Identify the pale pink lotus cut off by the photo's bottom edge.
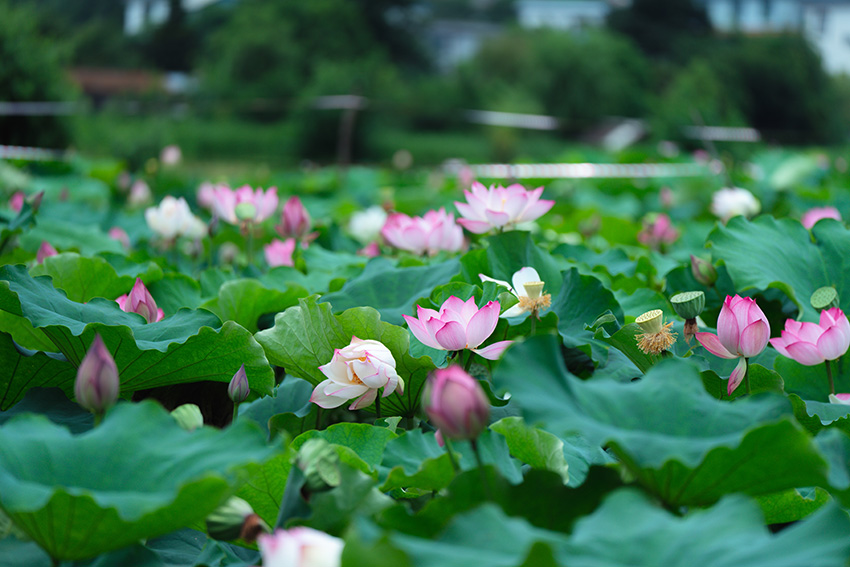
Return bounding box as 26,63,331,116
257,526,345,567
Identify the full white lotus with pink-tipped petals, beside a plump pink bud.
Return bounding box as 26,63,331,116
310,337,404,410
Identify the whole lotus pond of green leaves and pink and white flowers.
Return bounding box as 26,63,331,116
0,150,850,567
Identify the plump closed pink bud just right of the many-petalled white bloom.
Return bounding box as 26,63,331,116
422,366,490,439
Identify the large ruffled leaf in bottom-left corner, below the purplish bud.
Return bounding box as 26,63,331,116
0,402,274,559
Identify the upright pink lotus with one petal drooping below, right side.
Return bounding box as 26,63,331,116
695,295,770,395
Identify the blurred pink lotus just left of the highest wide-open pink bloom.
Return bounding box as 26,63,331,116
381,208,463,255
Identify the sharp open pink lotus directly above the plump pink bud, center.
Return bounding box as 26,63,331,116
403,296,513,360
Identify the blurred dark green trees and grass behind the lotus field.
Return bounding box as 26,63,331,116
0,0,850,165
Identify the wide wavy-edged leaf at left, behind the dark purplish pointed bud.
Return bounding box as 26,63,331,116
0,266,274,394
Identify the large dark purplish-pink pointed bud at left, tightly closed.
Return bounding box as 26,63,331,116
74,335,121,414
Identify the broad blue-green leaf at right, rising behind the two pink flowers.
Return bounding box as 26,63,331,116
709,216,850,321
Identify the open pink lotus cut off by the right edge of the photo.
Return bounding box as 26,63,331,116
770,307,850,366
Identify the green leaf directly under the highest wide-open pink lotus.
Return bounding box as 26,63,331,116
454,231,568,297
